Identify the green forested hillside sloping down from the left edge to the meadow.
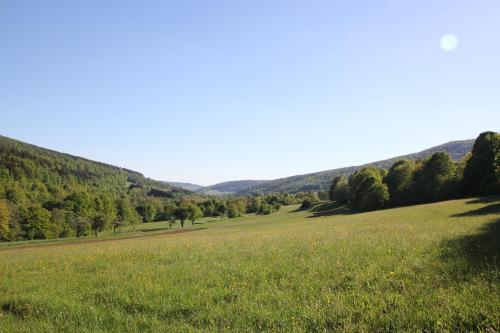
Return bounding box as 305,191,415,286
0,136,199,240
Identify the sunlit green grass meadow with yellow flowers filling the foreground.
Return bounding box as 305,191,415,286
0,198,500,333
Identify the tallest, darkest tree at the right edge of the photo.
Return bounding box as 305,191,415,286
462,132,500,195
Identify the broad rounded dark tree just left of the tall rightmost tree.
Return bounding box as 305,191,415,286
413,153,458,203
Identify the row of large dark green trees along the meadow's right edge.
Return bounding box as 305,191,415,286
329,132,500,211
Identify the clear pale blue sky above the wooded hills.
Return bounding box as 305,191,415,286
0,0,500,185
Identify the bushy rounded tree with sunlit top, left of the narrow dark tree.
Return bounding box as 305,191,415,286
349,167,389,211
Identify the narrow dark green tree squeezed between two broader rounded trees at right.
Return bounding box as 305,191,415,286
384,160,415,206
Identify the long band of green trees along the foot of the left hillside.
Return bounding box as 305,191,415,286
0,185,302,241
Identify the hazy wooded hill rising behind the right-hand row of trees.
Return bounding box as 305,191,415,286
240,140,474,194
